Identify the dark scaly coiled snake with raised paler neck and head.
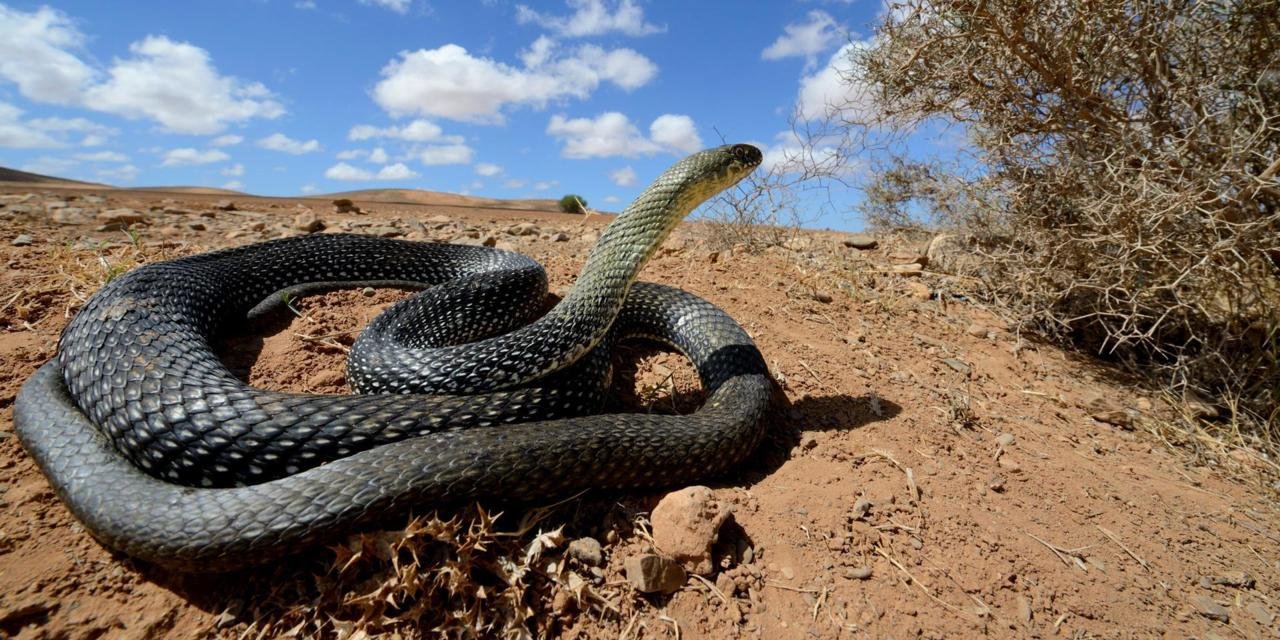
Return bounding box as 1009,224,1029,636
14,145,772,571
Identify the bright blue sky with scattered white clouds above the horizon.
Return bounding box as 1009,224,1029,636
0,0,901,228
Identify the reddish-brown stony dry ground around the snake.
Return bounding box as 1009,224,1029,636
0,186,1280,640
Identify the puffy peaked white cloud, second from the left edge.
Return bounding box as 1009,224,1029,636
83,36,284,134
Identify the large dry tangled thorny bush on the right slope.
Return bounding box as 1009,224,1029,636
849,0,1280,444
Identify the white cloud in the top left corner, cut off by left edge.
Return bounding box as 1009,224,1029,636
0,5,95,105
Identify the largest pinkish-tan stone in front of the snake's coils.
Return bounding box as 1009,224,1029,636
649,485,731,576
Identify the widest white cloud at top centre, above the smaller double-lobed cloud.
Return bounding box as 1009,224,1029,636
374,38,658,123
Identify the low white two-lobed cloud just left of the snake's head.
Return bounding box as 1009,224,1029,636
547,111,701,159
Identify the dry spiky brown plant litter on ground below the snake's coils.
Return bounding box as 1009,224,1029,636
244,504,608,639
